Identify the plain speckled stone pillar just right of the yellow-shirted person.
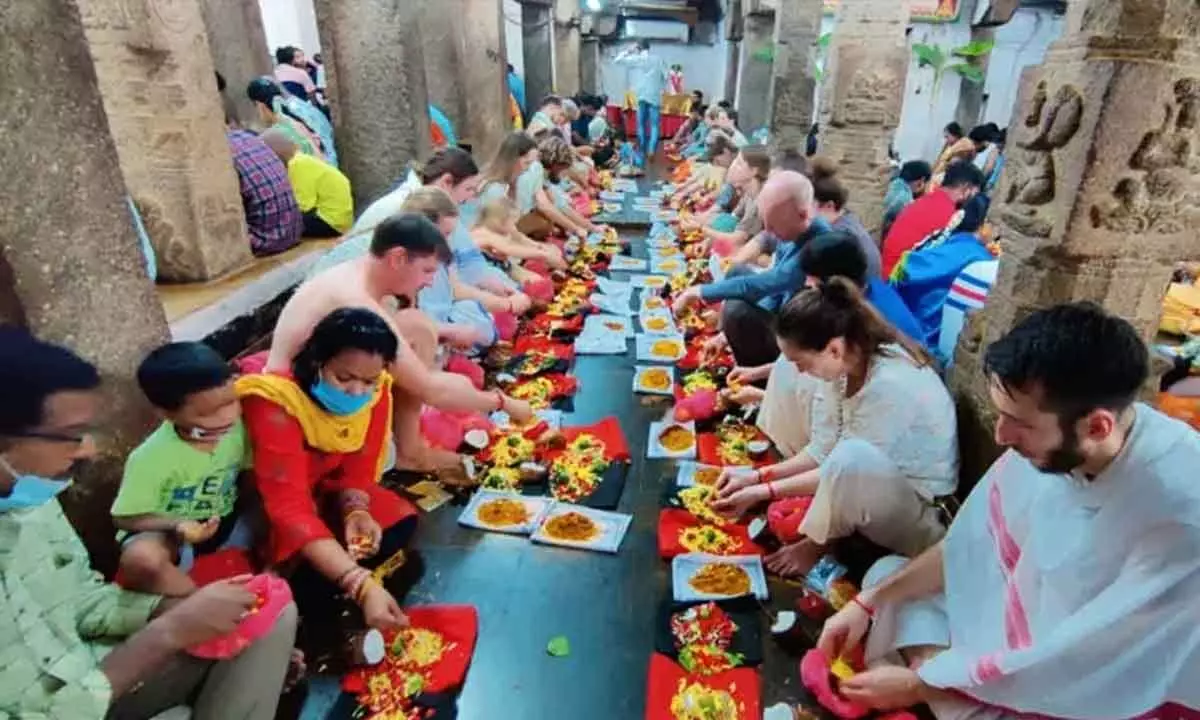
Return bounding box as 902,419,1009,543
316,0,430,208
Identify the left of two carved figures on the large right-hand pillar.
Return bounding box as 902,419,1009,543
1002,80,1084,238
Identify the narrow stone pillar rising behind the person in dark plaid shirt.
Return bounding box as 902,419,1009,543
200,0,274,125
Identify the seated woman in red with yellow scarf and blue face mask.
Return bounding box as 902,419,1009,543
236,308,416,629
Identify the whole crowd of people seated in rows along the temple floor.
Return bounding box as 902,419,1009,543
0,47,1200,720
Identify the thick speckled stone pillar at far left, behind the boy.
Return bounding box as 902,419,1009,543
0,0,168,570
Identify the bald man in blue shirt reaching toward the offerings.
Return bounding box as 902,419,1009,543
674,170,829,367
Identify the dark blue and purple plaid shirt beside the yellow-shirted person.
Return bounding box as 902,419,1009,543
226,130,304,254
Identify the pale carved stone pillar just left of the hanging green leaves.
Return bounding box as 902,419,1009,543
821,0,912,233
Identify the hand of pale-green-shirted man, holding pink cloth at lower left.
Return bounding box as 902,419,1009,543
155,575,257,649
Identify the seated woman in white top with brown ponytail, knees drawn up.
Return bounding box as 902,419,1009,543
714,277,959,576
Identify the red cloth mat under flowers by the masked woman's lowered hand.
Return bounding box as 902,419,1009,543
342,605,479,695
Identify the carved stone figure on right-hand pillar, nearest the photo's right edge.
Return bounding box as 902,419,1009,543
1088,78,1200,234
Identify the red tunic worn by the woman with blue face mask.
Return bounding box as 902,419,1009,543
241,386,416,563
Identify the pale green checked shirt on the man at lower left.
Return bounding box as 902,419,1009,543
0,500,161,720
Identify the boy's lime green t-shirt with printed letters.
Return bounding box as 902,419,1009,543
113,420,250,520
